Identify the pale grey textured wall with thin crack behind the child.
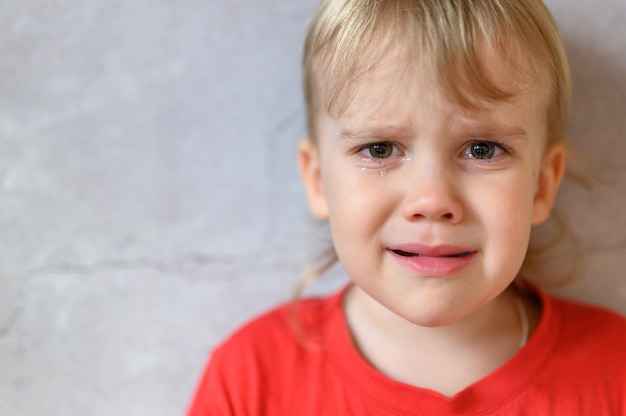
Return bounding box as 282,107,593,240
0,0,626,416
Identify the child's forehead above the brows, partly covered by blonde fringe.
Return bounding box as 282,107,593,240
318,42,552,128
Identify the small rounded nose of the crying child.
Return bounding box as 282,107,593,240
402,162,463,224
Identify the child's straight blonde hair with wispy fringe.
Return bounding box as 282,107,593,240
303,0,571,292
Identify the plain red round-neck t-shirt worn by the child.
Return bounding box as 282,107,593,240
188,291,626,416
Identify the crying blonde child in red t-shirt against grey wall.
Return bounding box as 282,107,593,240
189,0,626,416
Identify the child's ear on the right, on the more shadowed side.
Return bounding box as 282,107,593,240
532,143,566,225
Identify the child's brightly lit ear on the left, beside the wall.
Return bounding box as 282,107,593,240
298,139,328,220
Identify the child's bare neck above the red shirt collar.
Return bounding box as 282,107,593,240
345,287,525,395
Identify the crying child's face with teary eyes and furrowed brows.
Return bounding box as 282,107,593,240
300,46,564,326
